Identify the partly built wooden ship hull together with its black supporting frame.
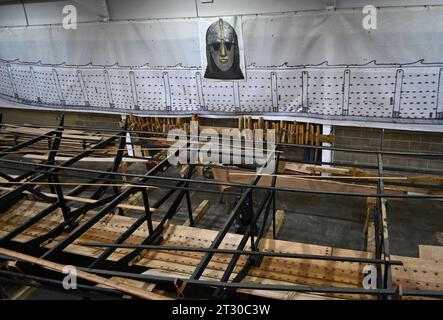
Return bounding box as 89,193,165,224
0,116,443,300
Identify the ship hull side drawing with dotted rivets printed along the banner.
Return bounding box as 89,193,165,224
0,59,443,123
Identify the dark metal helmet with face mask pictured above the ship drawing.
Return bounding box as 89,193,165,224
205,19,244,80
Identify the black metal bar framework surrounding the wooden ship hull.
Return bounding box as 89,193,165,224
0,116,443,299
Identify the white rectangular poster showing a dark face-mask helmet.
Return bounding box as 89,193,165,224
199,17,246,80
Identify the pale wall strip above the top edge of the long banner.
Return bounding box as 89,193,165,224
0,0,443,27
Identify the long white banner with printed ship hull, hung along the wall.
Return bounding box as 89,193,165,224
0,7,443,126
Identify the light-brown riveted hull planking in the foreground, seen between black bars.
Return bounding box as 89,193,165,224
0,200,443,299
